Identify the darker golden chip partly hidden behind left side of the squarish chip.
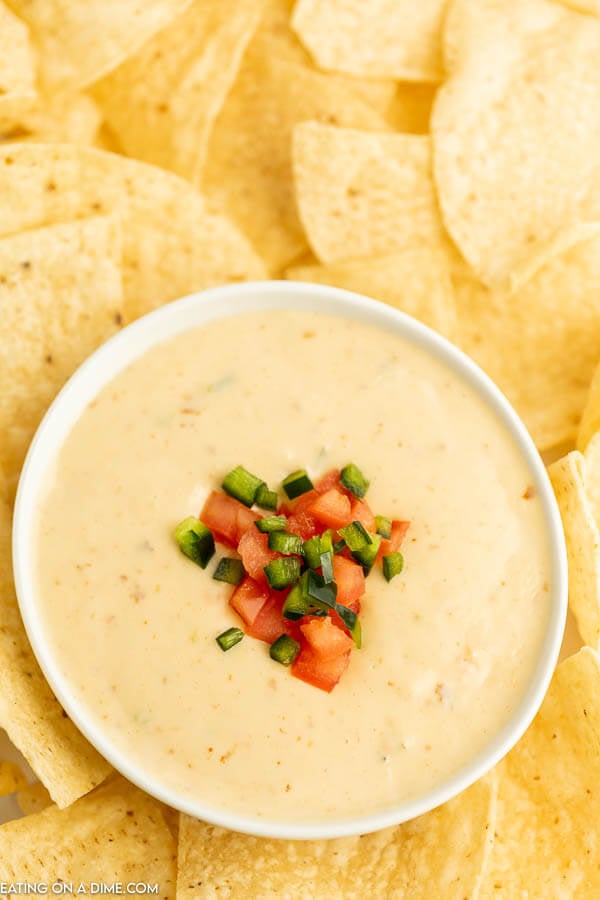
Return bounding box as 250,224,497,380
201,7,386,272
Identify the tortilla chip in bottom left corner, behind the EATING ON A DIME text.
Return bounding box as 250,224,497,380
0,778,177,898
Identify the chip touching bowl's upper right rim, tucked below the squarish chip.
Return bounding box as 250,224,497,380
285,249,456,339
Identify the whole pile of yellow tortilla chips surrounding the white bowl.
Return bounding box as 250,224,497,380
0,0,600,900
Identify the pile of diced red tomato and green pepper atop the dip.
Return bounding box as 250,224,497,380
175,463,410,691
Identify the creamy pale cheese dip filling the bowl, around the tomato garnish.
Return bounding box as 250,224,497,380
36,311,550,821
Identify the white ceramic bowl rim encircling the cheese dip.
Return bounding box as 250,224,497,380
13,281,567,838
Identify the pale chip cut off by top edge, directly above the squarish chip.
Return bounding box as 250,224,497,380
292,0,447,81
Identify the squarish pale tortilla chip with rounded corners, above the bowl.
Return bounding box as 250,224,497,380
293,122,447,263
